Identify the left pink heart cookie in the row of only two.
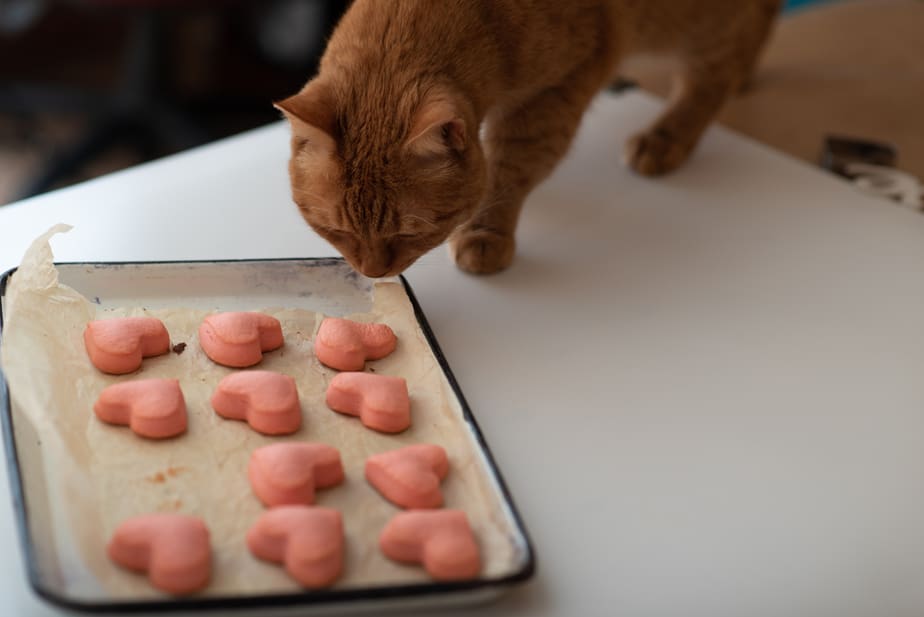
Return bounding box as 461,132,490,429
247,441,343,507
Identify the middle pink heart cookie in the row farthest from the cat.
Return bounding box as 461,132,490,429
247,506,344,588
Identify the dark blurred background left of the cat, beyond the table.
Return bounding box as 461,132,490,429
0,0,349,204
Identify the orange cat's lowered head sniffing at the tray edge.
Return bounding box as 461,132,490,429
276,78,486,277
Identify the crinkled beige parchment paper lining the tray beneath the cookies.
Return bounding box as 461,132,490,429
2,226,522,598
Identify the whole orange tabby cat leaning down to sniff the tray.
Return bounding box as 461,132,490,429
277,0,781,277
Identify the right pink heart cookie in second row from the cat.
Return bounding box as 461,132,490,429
327,373,411,433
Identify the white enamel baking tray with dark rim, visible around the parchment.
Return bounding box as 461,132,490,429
0,258,535,614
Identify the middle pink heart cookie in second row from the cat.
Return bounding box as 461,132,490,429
212,371,302,435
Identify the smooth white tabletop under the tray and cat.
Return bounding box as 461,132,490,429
0,94,924,617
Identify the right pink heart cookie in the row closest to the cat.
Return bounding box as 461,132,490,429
314,317,398,371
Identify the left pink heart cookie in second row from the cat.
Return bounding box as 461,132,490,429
93,379,187,439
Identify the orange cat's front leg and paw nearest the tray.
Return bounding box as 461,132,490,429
449,67,606,274
